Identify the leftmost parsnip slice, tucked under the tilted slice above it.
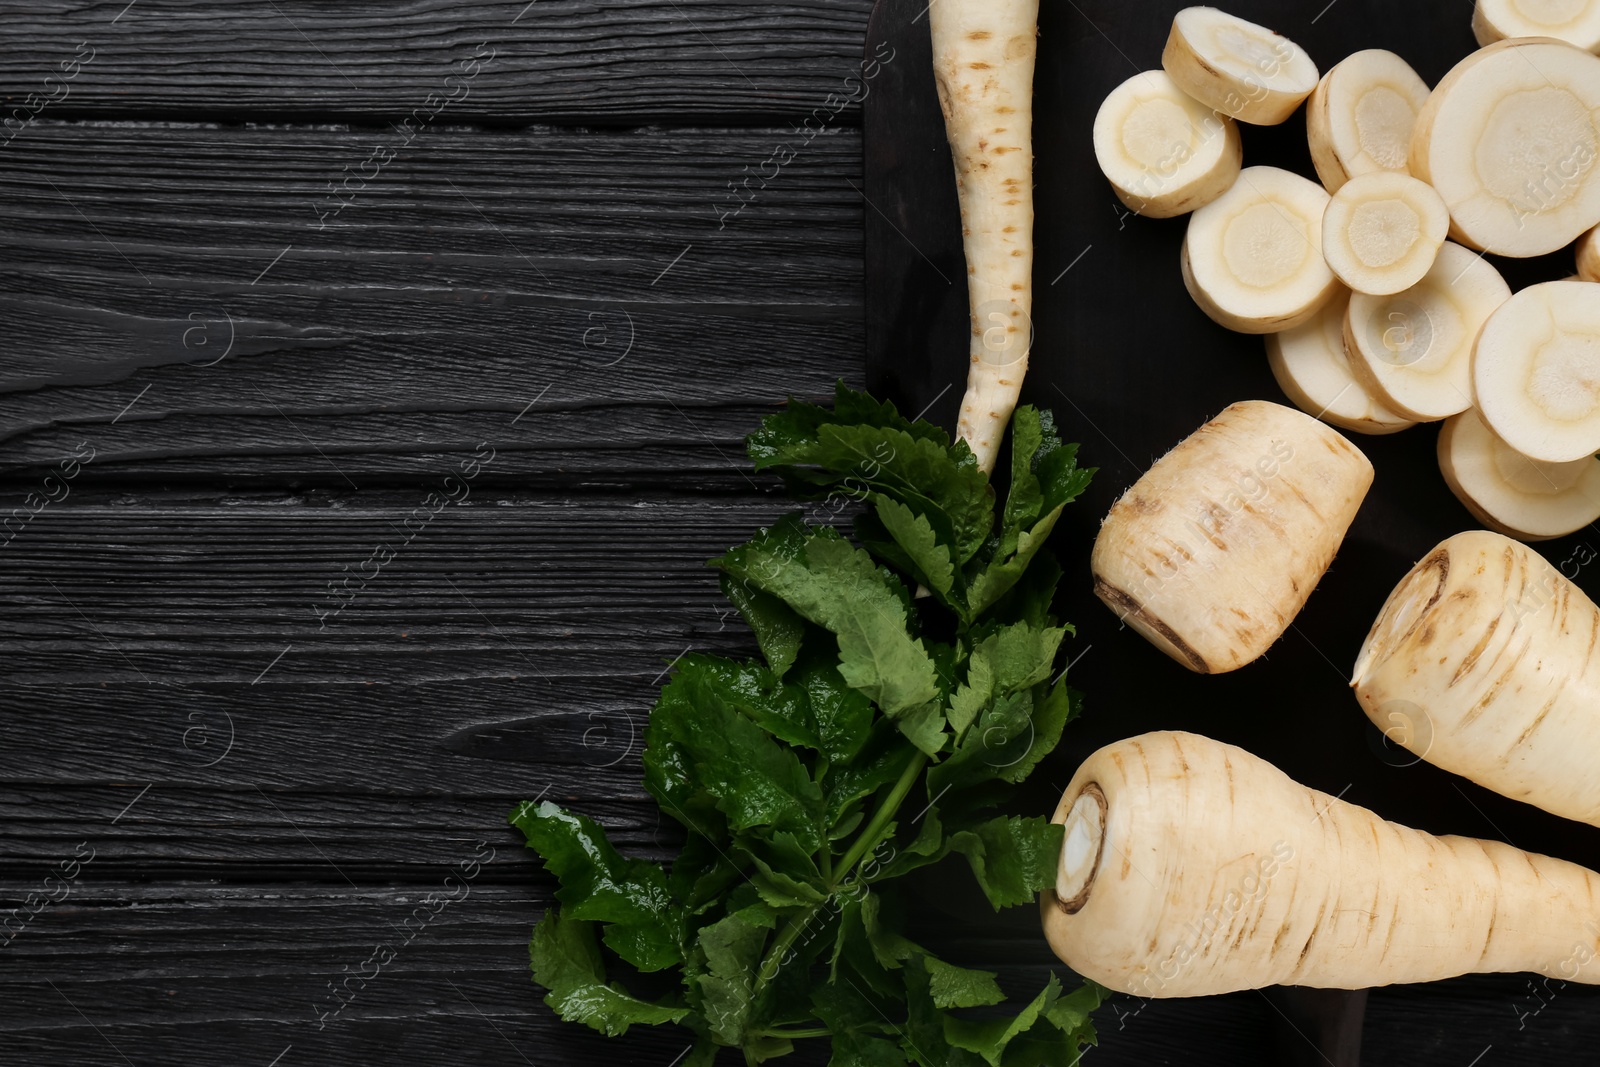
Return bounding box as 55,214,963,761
1094,70,1243,219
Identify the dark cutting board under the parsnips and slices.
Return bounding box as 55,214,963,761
864,0,1600,1067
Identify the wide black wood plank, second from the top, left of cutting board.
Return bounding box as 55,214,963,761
0,125,864,493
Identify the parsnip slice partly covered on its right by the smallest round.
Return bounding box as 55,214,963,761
1182,166,1339,333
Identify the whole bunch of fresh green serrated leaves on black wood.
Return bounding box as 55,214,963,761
512,386,1104,1067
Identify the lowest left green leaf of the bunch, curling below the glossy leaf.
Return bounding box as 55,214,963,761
528,907,688,1037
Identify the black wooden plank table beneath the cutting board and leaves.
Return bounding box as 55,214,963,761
0,0,1600,1067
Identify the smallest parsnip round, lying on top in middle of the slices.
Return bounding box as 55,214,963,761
1322,171,1450,296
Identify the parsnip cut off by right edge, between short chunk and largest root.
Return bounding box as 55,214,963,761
1350,530,1600,825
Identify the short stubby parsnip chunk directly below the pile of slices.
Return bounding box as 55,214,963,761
1090,400,1373,673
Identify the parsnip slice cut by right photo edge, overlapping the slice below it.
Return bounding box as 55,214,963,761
1472,282,1600,462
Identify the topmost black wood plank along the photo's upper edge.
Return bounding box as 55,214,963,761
0,0,872,125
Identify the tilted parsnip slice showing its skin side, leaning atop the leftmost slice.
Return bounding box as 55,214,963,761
1162,8,1317,126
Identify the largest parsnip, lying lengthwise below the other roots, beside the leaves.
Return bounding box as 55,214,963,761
1040,733,1600,997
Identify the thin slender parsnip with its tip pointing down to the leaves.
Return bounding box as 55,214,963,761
928,0,1038,470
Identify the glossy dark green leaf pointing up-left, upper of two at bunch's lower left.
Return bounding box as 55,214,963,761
510,801,683,971
